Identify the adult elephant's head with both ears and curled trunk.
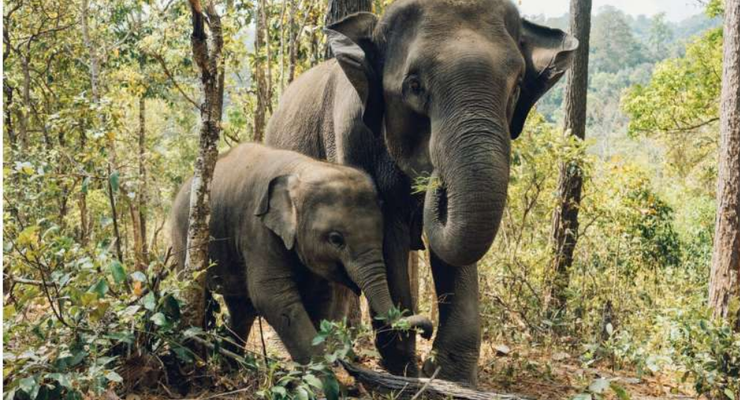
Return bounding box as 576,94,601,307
326,0,578,266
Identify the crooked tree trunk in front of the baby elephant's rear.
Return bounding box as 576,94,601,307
182,0,225,328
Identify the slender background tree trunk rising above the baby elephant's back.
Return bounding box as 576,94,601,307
252,0,270,143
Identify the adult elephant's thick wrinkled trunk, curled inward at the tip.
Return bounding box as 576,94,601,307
424,100,510,266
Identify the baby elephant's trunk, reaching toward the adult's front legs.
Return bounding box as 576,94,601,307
346,250,434,339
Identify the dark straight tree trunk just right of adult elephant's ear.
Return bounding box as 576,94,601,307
545,0,591,310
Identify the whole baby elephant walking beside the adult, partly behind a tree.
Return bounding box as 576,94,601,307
172,144,432,363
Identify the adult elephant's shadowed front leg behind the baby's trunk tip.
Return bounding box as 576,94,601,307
373,218,419,376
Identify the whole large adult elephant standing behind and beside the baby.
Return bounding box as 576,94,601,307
266,0,577,384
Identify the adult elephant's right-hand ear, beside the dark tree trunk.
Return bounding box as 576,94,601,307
509,19,578,139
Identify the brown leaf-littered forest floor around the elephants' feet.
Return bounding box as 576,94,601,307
117,323,696,400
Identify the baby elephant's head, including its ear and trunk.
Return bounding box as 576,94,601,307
255,165,432,338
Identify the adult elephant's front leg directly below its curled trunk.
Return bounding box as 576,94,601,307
423,251,481,386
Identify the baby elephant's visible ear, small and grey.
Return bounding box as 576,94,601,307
254,175,298,250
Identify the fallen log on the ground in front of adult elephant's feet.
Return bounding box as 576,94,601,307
342,362,532,400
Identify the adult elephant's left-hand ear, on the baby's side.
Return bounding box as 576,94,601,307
324,12,378,111
